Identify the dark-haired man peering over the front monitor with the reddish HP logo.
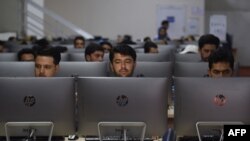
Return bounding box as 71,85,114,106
208,47,234,77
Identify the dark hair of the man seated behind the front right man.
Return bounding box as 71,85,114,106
198,34,220,49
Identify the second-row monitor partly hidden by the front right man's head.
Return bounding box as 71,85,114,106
174,62,239,77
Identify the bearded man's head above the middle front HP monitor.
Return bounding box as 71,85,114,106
109,45,136,77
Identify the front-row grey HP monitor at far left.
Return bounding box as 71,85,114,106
0,77,75,136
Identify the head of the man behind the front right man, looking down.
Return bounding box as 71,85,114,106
198,34,220,62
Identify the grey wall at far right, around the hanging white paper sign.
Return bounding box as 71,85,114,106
205,0,250,66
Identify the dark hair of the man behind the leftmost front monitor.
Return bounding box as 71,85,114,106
36,47,61,65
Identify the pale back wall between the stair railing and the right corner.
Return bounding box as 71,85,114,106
45,0,204,39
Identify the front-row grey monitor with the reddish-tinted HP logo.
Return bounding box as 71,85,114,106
174,77,250,136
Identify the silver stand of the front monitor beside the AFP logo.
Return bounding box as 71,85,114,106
196,121,243,141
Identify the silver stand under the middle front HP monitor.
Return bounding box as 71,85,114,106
98,122,146,141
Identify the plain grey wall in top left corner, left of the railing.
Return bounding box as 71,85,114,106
0,0,22,34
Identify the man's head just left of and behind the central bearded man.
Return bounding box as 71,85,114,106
85,43,104,62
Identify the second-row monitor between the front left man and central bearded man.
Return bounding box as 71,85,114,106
56,62,108,77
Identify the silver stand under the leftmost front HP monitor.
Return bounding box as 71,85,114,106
5,122,54,141
